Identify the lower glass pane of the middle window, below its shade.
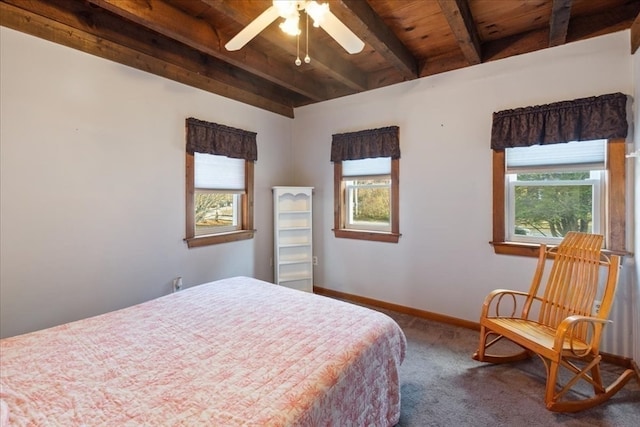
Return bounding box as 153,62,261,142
346,177,391,231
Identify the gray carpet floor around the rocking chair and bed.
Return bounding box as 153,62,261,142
372,307,640,427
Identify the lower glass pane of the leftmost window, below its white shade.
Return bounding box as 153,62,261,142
195,190,241,236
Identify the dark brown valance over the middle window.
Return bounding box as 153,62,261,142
331,126,400,162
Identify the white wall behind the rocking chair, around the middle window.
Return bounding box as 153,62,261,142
293,31,637,358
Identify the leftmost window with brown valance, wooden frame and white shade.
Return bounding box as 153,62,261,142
185,119,257,248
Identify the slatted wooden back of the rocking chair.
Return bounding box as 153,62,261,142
538,232,608,340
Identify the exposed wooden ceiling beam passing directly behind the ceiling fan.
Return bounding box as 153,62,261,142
202,0,369,91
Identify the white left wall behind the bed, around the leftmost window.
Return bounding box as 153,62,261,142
0,27,292,337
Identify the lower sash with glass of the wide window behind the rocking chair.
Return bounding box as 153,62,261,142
508,171,602,242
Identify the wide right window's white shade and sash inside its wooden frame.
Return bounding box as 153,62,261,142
505,140,606,244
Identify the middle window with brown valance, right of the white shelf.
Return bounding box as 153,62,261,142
331,126,400,243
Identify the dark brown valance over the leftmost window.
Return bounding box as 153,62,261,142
187,117,258,161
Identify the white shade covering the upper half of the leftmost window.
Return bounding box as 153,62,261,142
194,153,245,190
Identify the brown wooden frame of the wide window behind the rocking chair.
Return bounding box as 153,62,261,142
490,138,628,257
